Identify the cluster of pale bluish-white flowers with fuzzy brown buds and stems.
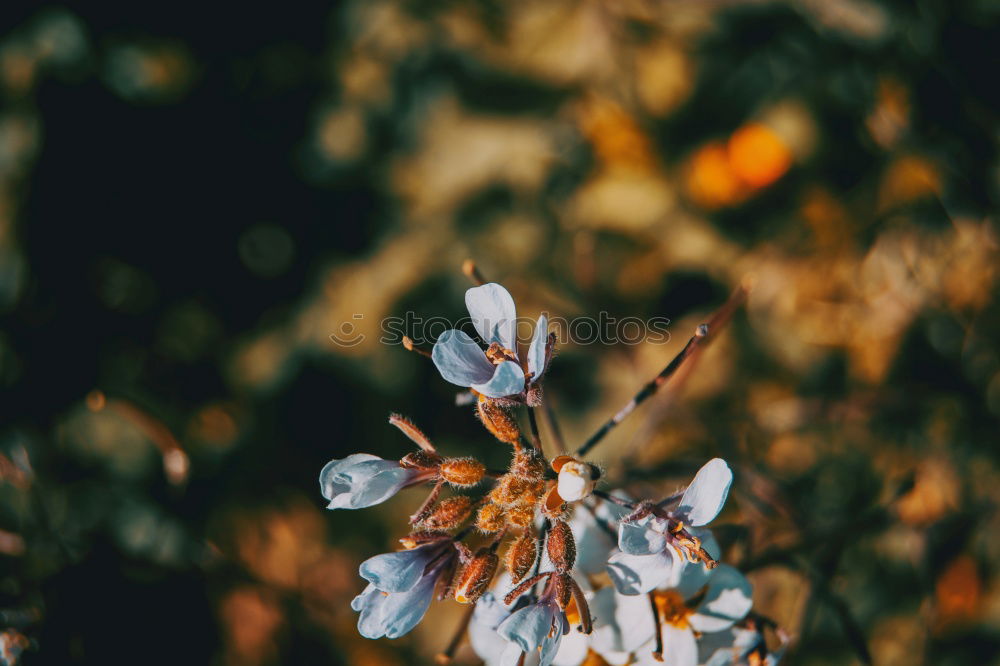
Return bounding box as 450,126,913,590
320,272,784,666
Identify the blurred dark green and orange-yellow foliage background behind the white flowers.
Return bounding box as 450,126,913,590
0,0,1000,666
